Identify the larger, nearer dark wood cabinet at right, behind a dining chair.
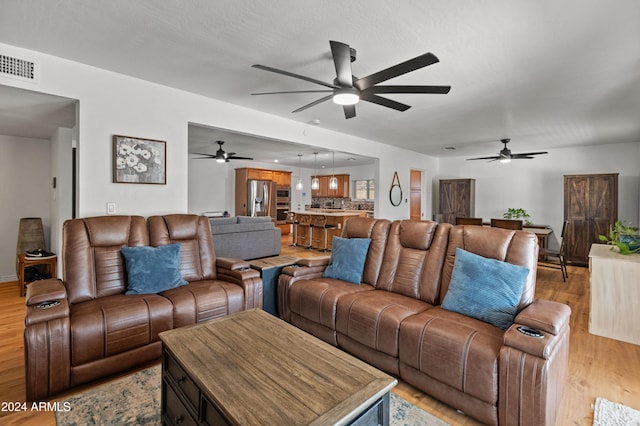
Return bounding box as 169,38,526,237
564,173,618,266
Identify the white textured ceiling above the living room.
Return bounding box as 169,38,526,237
0,0,640,164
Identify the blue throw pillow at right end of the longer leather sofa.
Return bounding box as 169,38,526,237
442,248,529,330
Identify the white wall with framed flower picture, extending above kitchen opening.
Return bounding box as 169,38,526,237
0,42,437,223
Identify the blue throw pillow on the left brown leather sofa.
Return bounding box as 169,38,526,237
121,244,187,294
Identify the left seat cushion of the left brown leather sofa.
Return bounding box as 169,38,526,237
70,294,173,366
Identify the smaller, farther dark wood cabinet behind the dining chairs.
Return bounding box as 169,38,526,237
440,179,476,225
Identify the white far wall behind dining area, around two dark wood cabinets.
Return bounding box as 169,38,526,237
434,142,640,250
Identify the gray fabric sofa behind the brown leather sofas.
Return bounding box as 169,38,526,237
209,216,280,260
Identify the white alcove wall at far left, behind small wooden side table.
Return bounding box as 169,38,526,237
0,135,51,282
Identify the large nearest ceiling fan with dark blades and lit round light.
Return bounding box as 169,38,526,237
252,41,451,118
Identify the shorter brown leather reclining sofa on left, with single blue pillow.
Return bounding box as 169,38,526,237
24,214,262,401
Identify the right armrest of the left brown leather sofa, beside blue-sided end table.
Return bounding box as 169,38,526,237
216,257,262,309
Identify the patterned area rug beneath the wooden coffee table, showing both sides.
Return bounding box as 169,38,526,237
56,365,448,426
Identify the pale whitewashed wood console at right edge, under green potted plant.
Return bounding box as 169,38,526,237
589,244,640,345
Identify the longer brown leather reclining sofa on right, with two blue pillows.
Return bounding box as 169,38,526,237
278,218,571,425
